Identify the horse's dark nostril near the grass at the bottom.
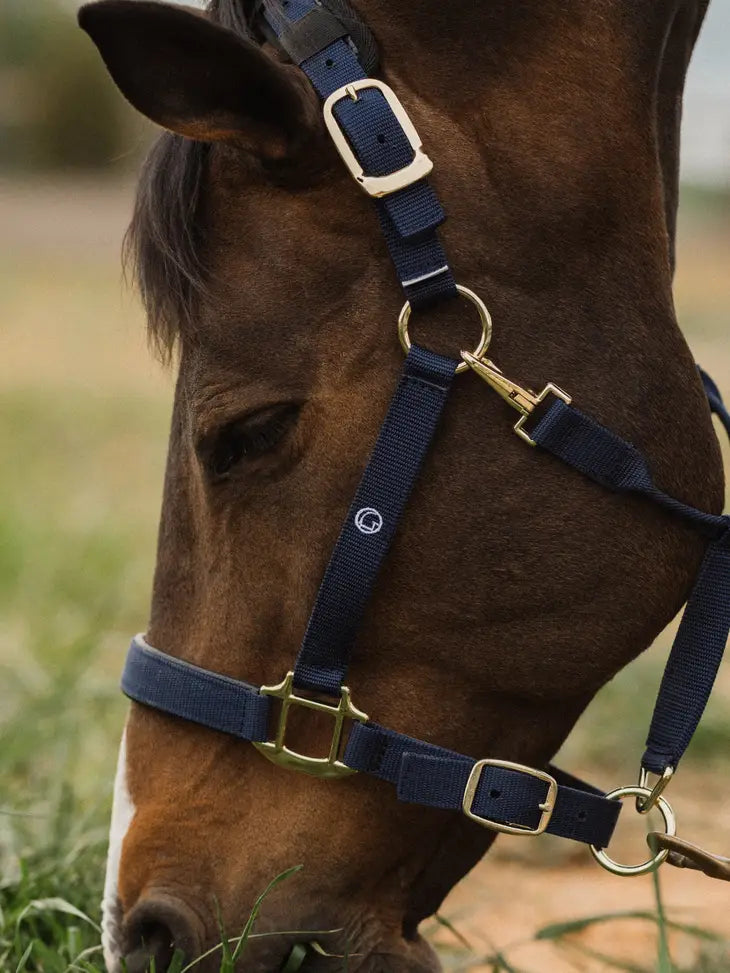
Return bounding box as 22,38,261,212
124,896,200,973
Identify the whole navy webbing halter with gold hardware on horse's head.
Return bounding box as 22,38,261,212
122,0,730,875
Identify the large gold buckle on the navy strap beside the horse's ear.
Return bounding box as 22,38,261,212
324,78,433,197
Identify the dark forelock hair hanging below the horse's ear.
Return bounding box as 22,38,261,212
124,0,255,358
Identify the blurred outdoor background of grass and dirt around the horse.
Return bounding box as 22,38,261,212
0,0,730,973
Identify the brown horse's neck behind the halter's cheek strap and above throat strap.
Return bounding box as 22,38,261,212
346,0,713,505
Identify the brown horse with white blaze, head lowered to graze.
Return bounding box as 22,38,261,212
79,0,723,973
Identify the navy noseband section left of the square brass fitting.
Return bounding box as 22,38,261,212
122,635,270,741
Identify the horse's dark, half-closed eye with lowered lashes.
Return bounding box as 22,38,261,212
198,402,300,480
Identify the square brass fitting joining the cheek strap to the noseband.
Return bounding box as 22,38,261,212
254,672,368,780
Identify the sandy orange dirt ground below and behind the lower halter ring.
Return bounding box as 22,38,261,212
438,770,730,973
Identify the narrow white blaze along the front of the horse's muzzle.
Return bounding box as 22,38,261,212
101,730,135,973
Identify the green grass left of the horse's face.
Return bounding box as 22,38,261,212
0,390,165,973
